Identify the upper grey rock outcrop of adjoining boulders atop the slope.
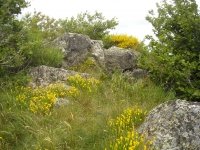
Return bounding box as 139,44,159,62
54,33,146,78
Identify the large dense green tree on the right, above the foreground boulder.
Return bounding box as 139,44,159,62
141,0,200,101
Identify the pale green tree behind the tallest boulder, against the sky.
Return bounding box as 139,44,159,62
61,12,118,40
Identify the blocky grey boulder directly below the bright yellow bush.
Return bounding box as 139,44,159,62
104,47,138,72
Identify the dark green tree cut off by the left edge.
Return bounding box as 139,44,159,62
0,0,27,74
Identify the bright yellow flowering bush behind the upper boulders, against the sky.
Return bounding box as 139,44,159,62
104,34,139,50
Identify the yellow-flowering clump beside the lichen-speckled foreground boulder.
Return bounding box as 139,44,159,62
108,108,151,150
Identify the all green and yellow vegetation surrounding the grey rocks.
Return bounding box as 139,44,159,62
0,0,200,150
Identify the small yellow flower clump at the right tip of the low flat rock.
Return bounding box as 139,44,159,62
67,74,100,93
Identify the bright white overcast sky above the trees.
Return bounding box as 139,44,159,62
23,0,200,40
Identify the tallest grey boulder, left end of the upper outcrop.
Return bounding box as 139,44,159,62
55,33,92,68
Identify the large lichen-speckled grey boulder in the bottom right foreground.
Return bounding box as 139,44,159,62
140,100,200,150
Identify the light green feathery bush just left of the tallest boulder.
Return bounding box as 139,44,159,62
22,12,64,67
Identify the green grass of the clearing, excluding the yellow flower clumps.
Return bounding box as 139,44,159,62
0,68,174,150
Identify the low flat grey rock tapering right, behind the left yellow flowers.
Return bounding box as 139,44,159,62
29,66,89,87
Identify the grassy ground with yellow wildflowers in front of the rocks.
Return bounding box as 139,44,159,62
0,73,173,150
